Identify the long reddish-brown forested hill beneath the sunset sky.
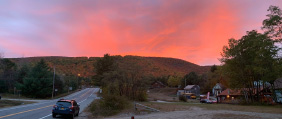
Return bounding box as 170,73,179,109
10,56,210,77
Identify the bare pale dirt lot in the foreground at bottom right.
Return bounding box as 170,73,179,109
105,104,282,119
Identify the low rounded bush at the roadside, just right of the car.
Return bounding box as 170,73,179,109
90,95,129,117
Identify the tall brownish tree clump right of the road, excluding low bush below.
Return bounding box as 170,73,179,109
94,54,147,101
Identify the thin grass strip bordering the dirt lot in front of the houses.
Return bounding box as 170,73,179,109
142,102,282,114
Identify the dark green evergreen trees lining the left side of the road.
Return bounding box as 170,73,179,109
0,58,90,98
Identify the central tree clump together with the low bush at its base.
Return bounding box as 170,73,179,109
90,54,148,116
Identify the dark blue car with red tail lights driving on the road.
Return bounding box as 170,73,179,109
52,99,80,119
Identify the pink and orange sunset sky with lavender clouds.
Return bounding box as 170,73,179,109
0,0,282,65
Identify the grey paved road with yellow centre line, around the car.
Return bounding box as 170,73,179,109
0,88,99,119
